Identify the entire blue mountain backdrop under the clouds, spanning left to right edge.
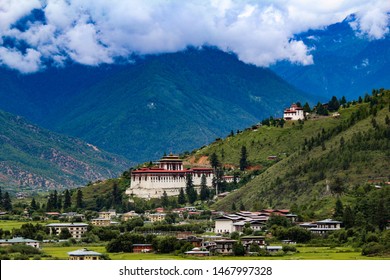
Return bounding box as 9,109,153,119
0,16,390,190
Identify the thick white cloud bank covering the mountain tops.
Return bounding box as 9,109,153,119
0,0,390,73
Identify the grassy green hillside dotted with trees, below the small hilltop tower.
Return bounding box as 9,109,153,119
192,90,390,217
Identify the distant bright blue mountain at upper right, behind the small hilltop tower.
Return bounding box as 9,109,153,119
271,15,390,100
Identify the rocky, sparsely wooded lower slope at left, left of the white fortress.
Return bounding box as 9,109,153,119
0,111,130,191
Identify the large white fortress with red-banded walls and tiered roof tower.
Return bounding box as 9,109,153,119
126,154,214,199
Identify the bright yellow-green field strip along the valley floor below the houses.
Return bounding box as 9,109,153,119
42,245,390,260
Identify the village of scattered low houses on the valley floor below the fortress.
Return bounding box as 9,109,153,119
0,203,348,260
